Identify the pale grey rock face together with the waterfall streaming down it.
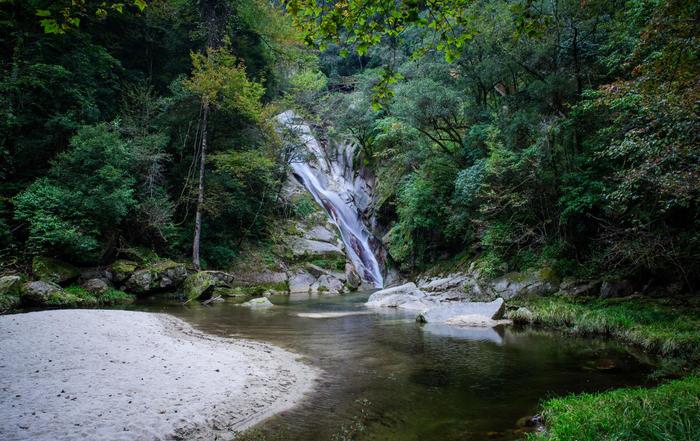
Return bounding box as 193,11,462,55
277,111,384,287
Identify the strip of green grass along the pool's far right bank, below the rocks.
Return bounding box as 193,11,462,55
508,297,700,362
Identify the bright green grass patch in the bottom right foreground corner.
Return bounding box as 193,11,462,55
527,377,700,441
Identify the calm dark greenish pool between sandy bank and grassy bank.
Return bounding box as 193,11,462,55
137,293,649,441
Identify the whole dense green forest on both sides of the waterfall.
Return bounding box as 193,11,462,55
0,0,700,290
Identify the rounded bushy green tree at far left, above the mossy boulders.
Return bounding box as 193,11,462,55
14,124,136,261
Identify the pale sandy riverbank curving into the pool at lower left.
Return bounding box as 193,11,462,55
0,310,318,440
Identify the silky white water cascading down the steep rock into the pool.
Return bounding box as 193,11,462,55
277,110,384,288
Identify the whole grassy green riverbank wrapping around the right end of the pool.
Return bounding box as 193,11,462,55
509,296,700,441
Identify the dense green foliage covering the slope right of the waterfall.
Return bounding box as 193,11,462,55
296,0,700,287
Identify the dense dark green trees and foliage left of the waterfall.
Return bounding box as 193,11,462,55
0,0,313,266
